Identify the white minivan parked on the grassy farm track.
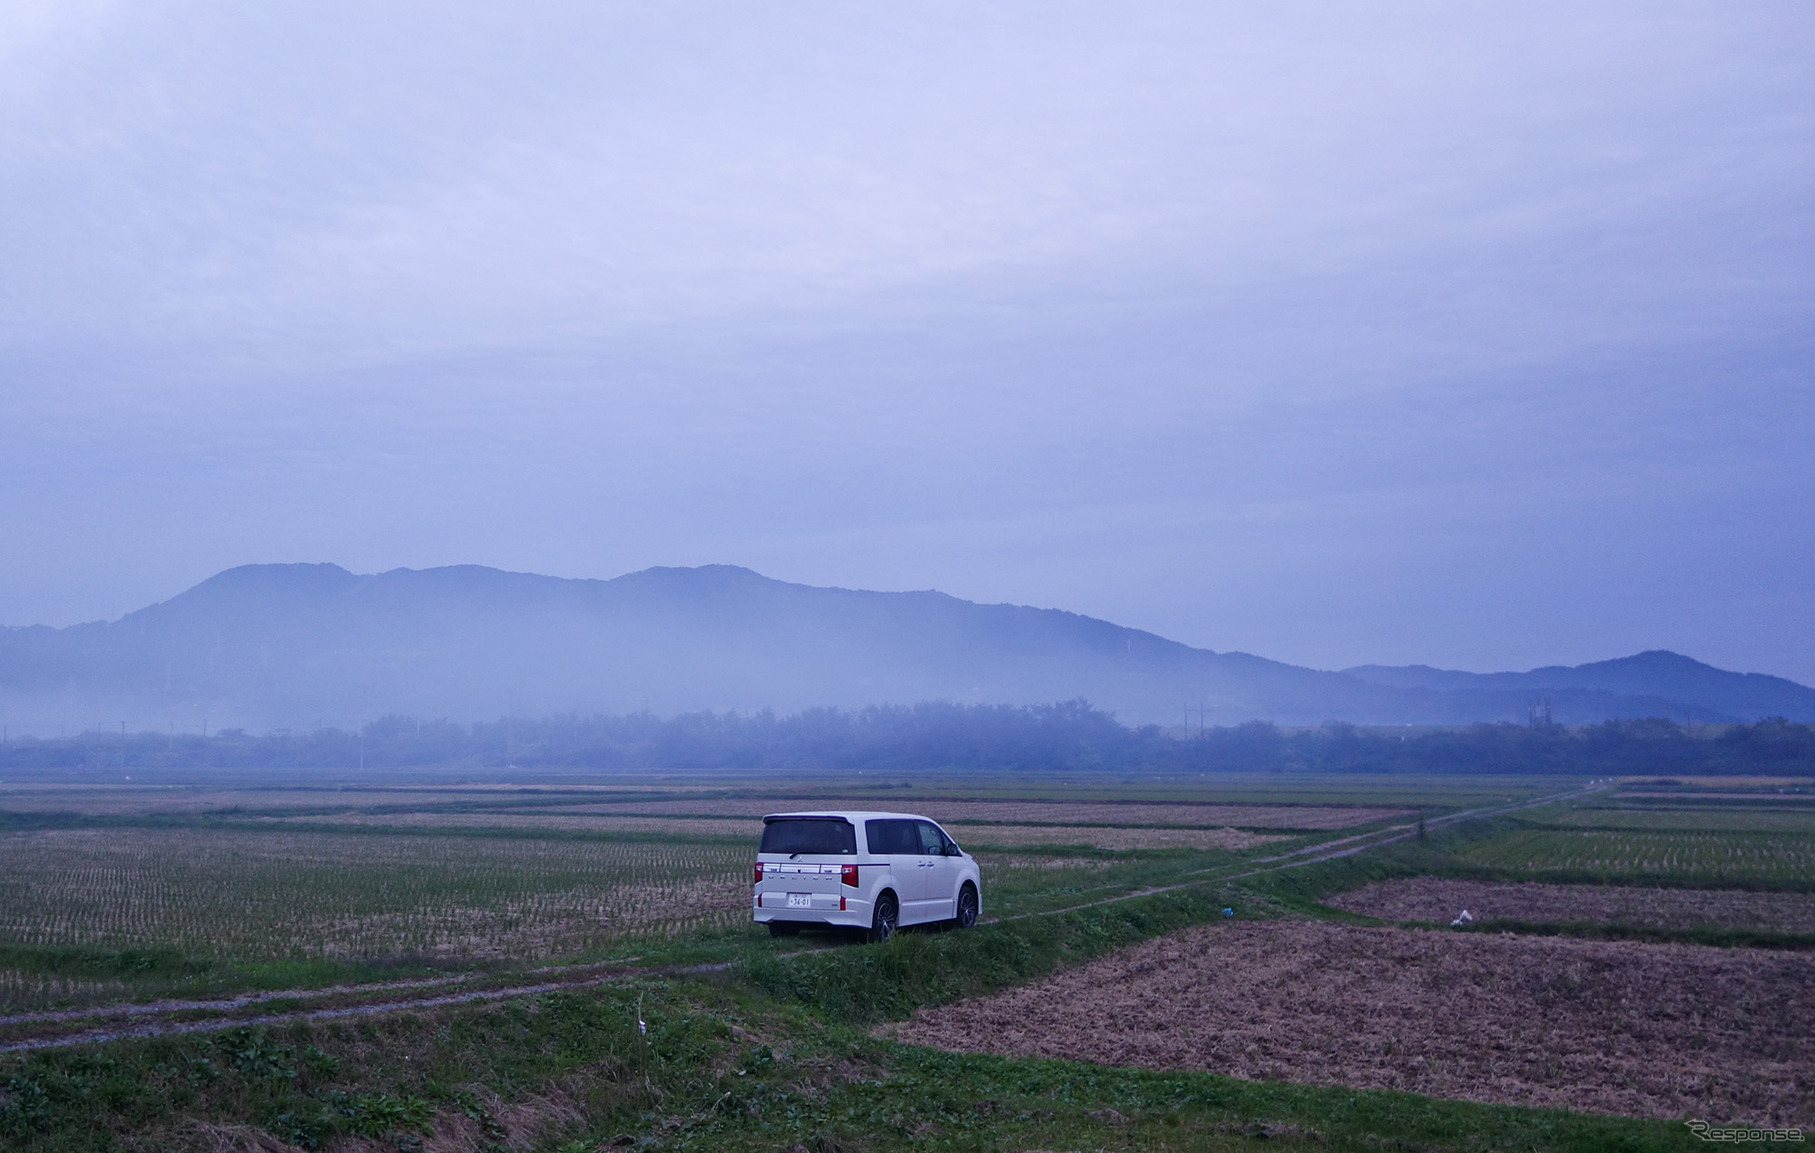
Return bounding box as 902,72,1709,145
753,812,984,941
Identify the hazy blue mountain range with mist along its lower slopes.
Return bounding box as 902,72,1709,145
0,565,1815,735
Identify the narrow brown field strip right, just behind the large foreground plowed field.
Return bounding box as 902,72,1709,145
1325,877,1815,933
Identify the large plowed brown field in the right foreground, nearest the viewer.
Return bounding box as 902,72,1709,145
884,921,1815,1126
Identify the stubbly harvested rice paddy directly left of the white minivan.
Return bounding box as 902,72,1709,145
0,828,750,961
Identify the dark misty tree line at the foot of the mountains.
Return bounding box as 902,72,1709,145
0,701,1815,775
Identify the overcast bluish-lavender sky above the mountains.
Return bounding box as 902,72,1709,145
0,0,1815,683
